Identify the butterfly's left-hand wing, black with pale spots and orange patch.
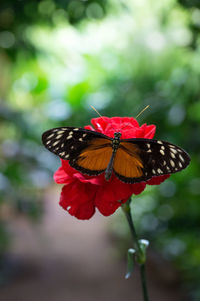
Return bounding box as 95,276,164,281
42,127,112,176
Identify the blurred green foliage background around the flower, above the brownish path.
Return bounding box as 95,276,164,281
0,0,200,300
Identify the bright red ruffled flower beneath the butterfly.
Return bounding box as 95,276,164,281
54,117,169,219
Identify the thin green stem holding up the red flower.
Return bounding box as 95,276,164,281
122,200,149,301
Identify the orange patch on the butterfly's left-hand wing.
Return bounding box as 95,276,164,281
76,138,112,171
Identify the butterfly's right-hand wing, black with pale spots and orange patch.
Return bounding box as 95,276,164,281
113,138,190,183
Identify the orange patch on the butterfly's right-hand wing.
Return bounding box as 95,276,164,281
113,142,143,178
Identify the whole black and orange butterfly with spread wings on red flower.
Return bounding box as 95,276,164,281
42,127,190,183
